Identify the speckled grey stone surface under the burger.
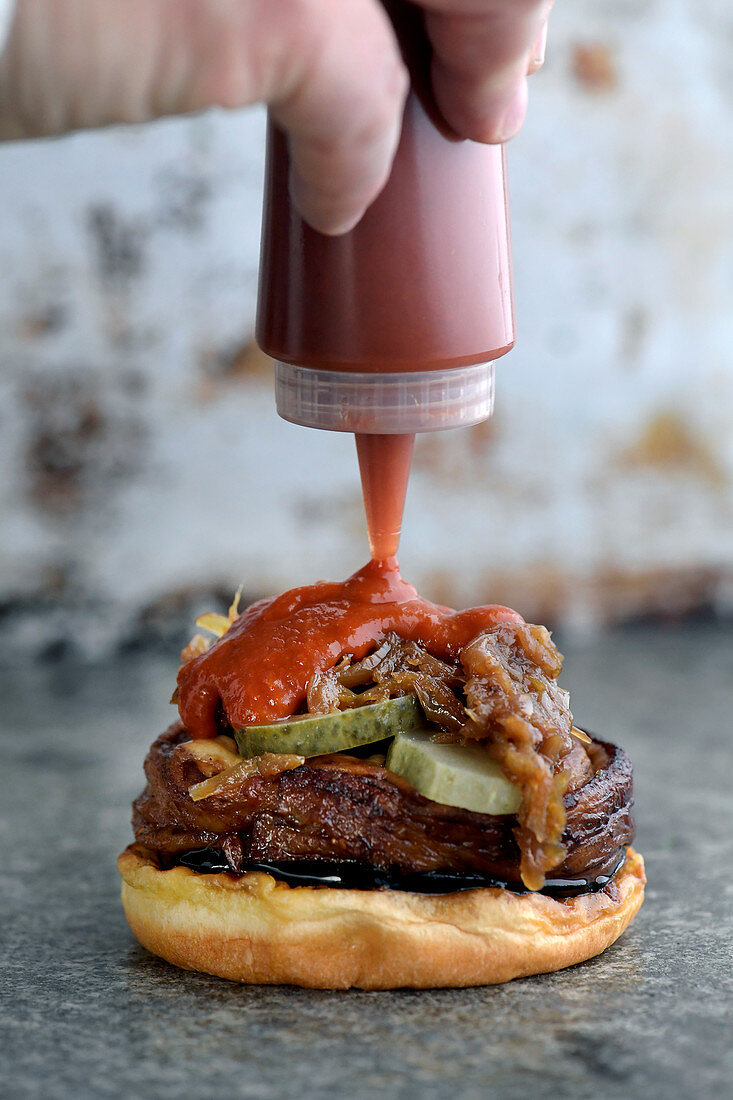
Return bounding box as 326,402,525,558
0,627,733,1100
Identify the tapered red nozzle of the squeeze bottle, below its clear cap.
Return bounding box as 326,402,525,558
355,435,415,561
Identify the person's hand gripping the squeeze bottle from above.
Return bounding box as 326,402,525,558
0,0,551,233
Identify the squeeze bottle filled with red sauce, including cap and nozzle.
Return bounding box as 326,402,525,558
256,4,514,559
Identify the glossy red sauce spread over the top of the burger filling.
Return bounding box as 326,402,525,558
178,558,523,739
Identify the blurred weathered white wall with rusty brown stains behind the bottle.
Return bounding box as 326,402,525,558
0,0,733,659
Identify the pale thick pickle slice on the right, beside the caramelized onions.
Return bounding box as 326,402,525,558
385,732,522,814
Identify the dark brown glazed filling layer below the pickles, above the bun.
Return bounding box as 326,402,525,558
133,723,634,882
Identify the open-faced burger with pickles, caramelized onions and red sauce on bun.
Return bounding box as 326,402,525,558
118,561,645,989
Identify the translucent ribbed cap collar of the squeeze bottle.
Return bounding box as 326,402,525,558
275,362,494,436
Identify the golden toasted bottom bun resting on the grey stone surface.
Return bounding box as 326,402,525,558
118,844,646,989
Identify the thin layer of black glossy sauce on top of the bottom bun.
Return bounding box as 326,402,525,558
175,848,626,899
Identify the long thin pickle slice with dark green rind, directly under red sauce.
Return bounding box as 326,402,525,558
234,695,425,757
